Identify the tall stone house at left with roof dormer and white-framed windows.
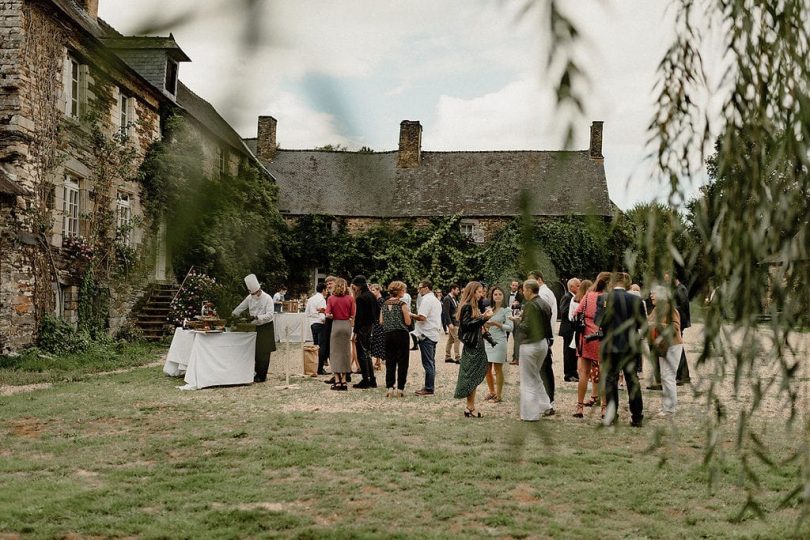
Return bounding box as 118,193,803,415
0,0,271,353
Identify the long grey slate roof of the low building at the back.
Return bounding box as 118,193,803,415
246,148,612,218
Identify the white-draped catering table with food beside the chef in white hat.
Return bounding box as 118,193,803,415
163,328,256,390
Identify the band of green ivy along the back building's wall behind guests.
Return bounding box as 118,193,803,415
283,215,635,291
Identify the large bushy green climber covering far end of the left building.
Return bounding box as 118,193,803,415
138,115,287,306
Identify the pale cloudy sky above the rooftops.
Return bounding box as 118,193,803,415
99,0,716,209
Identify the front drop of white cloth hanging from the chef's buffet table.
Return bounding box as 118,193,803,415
180,332,256,389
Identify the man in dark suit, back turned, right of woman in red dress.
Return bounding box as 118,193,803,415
599,272,645,427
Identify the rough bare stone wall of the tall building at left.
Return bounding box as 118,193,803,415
0,0,160,353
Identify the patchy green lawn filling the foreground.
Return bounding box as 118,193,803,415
0,340,810,539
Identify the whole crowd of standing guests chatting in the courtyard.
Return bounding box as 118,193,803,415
288,272,689,426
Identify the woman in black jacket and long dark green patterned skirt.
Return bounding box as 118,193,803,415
453,281,492,418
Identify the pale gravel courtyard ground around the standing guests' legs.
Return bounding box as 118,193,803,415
268,324,810,421
